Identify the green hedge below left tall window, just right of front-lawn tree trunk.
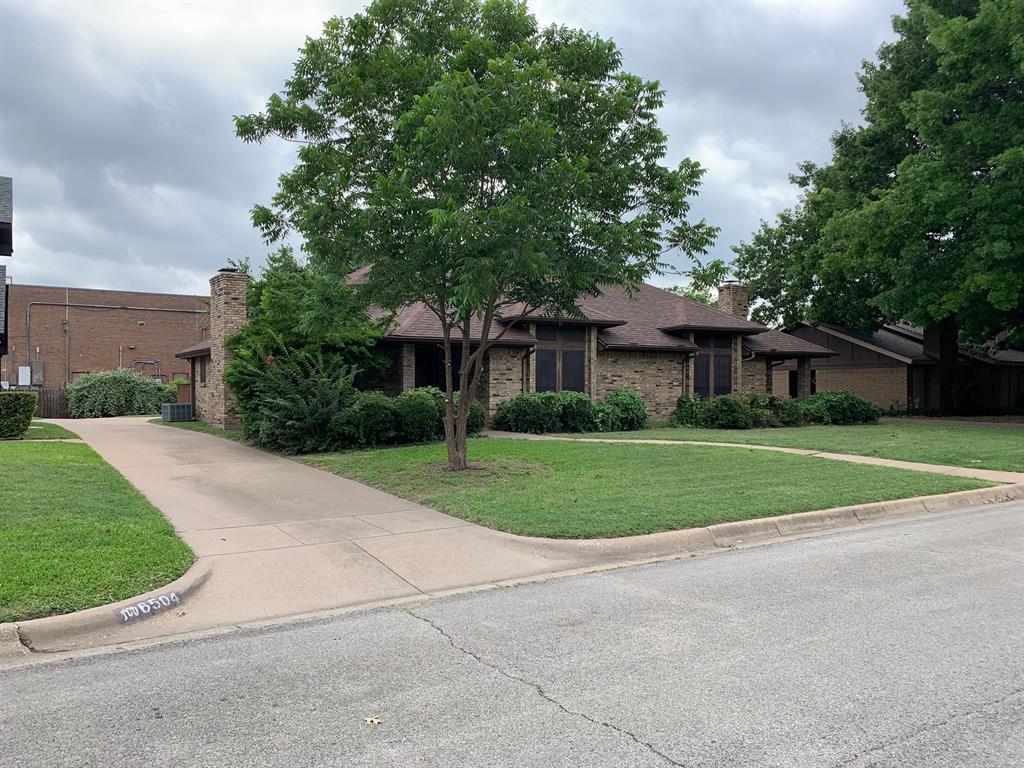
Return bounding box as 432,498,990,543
492,389,647,434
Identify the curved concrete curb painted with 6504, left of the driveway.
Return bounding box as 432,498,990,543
8,558,213,658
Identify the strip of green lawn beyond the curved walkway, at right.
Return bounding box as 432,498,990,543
594,419,1024,472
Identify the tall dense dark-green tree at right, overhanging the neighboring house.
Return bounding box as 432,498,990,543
733,0,1024,408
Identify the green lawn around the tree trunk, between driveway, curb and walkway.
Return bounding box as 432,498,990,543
305,438,988,539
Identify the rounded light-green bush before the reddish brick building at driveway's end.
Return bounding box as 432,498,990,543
68,369,177,419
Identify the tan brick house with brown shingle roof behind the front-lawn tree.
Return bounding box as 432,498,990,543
349,268,831,418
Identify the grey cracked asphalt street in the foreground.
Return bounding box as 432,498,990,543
0,503,1024,768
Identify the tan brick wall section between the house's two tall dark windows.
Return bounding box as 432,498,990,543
594,350,685,419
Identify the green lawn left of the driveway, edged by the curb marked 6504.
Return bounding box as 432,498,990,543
0,442,195,622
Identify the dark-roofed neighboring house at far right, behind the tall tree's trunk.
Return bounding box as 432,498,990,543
774,323,1024,413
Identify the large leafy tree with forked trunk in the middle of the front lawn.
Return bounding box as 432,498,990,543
237,0,716,469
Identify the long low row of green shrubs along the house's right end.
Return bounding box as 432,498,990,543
672,390,882,429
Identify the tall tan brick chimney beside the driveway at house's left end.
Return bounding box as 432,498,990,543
207,267,249,429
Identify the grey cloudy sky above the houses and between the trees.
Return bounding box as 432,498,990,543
0,0,901,293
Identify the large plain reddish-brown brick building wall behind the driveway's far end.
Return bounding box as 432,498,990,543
0,284,207,388
